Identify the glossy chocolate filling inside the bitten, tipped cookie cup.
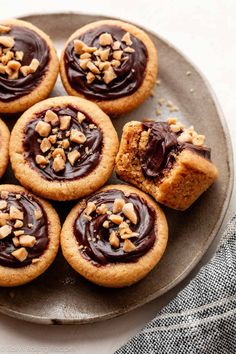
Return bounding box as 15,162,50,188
140,122,211,179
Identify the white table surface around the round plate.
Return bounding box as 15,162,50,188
0,0,236,354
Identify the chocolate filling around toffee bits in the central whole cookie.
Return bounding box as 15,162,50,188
23,106,103,181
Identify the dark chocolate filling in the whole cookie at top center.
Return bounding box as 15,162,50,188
64,25,148,100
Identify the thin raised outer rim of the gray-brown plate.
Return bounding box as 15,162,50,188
0,11,234,325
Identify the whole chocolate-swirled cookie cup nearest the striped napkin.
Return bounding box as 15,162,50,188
61,185,168,288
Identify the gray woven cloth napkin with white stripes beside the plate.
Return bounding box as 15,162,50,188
116,215,236,354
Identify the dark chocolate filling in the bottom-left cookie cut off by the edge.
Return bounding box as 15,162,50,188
0,193,48,268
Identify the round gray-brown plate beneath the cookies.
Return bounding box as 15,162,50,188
0,14,233,324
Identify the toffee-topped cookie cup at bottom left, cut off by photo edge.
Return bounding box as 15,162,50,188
0,184,60,286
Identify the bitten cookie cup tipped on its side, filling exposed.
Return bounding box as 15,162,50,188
115,118,218,210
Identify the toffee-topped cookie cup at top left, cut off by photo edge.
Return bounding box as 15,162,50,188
0,20,59,113
